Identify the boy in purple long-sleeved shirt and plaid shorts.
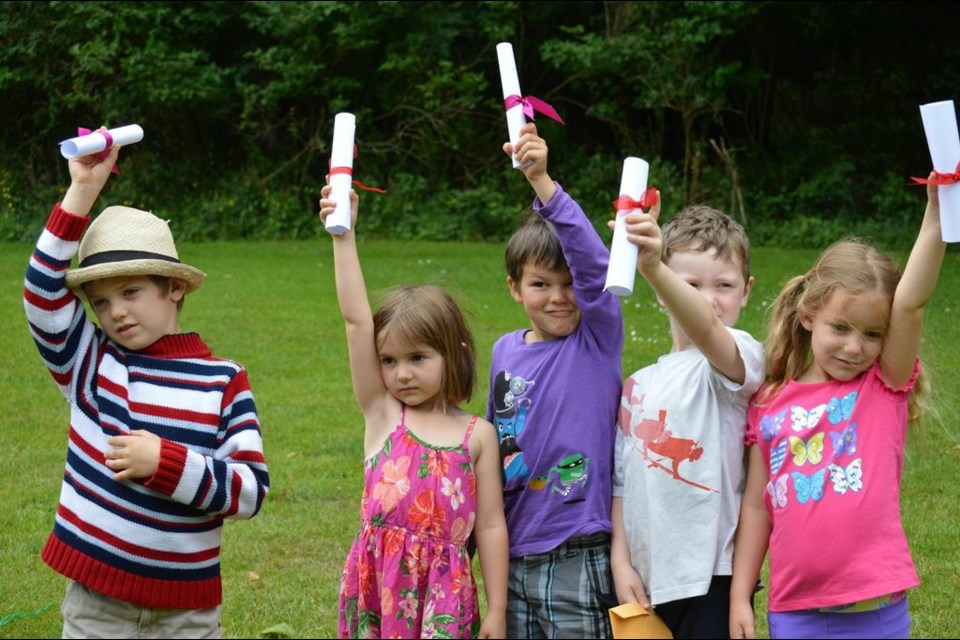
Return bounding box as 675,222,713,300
487,123,623,638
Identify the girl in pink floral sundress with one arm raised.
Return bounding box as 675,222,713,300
320,186,508,638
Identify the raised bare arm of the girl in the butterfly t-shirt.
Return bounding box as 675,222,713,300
880,180,947,389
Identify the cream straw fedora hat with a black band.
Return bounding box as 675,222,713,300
67,206,207,298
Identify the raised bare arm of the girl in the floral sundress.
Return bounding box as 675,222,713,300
320,185,387,424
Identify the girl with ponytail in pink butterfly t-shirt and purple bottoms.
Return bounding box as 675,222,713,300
730,174,946,638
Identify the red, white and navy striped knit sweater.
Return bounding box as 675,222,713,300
24,204,269,609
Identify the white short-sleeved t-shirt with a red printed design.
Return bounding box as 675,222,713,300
613,328,765,605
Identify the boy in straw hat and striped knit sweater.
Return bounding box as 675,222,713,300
24,134,269,638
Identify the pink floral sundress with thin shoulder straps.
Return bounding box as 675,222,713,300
338,406,480,638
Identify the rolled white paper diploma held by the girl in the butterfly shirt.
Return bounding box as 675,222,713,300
920,100,960,242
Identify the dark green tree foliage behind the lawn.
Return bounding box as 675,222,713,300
0,0,960,248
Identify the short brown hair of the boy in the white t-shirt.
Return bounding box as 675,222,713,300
663,204,750,282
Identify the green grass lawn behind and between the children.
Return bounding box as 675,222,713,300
0,238,960,638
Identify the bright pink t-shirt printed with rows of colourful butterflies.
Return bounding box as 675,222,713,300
746,361,920,612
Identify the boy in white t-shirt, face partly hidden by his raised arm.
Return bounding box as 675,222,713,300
611,199,764,638
